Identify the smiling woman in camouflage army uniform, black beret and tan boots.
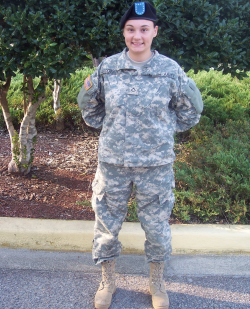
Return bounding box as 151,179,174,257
77,2,203,309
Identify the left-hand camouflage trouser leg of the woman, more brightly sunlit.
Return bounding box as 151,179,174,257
92,162,132,264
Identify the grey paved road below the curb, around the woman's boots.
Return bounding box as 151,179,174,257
0,248,250,309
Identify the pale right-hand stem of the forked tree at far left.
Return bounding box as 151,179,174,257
8,76,47,175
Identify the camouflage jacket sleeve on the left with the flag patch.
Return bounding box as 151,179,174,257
77,64,105,129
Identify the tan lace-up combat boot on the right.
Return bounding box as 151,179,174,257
149,263,169,309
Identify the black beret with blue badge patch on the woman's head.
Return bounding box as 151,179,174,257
120,1,157,29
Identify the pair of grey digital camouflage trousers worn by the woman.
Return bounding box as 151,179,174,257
92,162,174,264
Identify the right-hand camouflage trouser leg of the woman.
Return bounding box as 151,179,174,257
134,164,174,262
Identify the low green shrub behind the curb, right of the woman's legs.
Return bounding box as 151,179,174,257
173,116,250,223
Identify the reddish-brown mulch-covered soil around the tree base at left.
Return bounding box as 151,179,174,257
0,128,98,220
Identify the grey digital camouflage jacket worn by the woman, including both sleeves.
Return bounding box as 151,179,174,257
77,49,203,167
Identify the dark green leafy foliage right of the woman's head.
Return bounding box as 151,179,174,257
153,0,250,77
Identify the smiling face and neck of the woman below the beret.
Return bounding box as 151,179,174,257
123,19,158,61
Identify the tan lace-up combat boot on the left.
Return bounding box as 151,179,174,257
95,260,116,309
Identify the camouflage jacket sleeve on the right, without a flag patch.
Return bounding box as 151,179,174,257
171,69,203,132
